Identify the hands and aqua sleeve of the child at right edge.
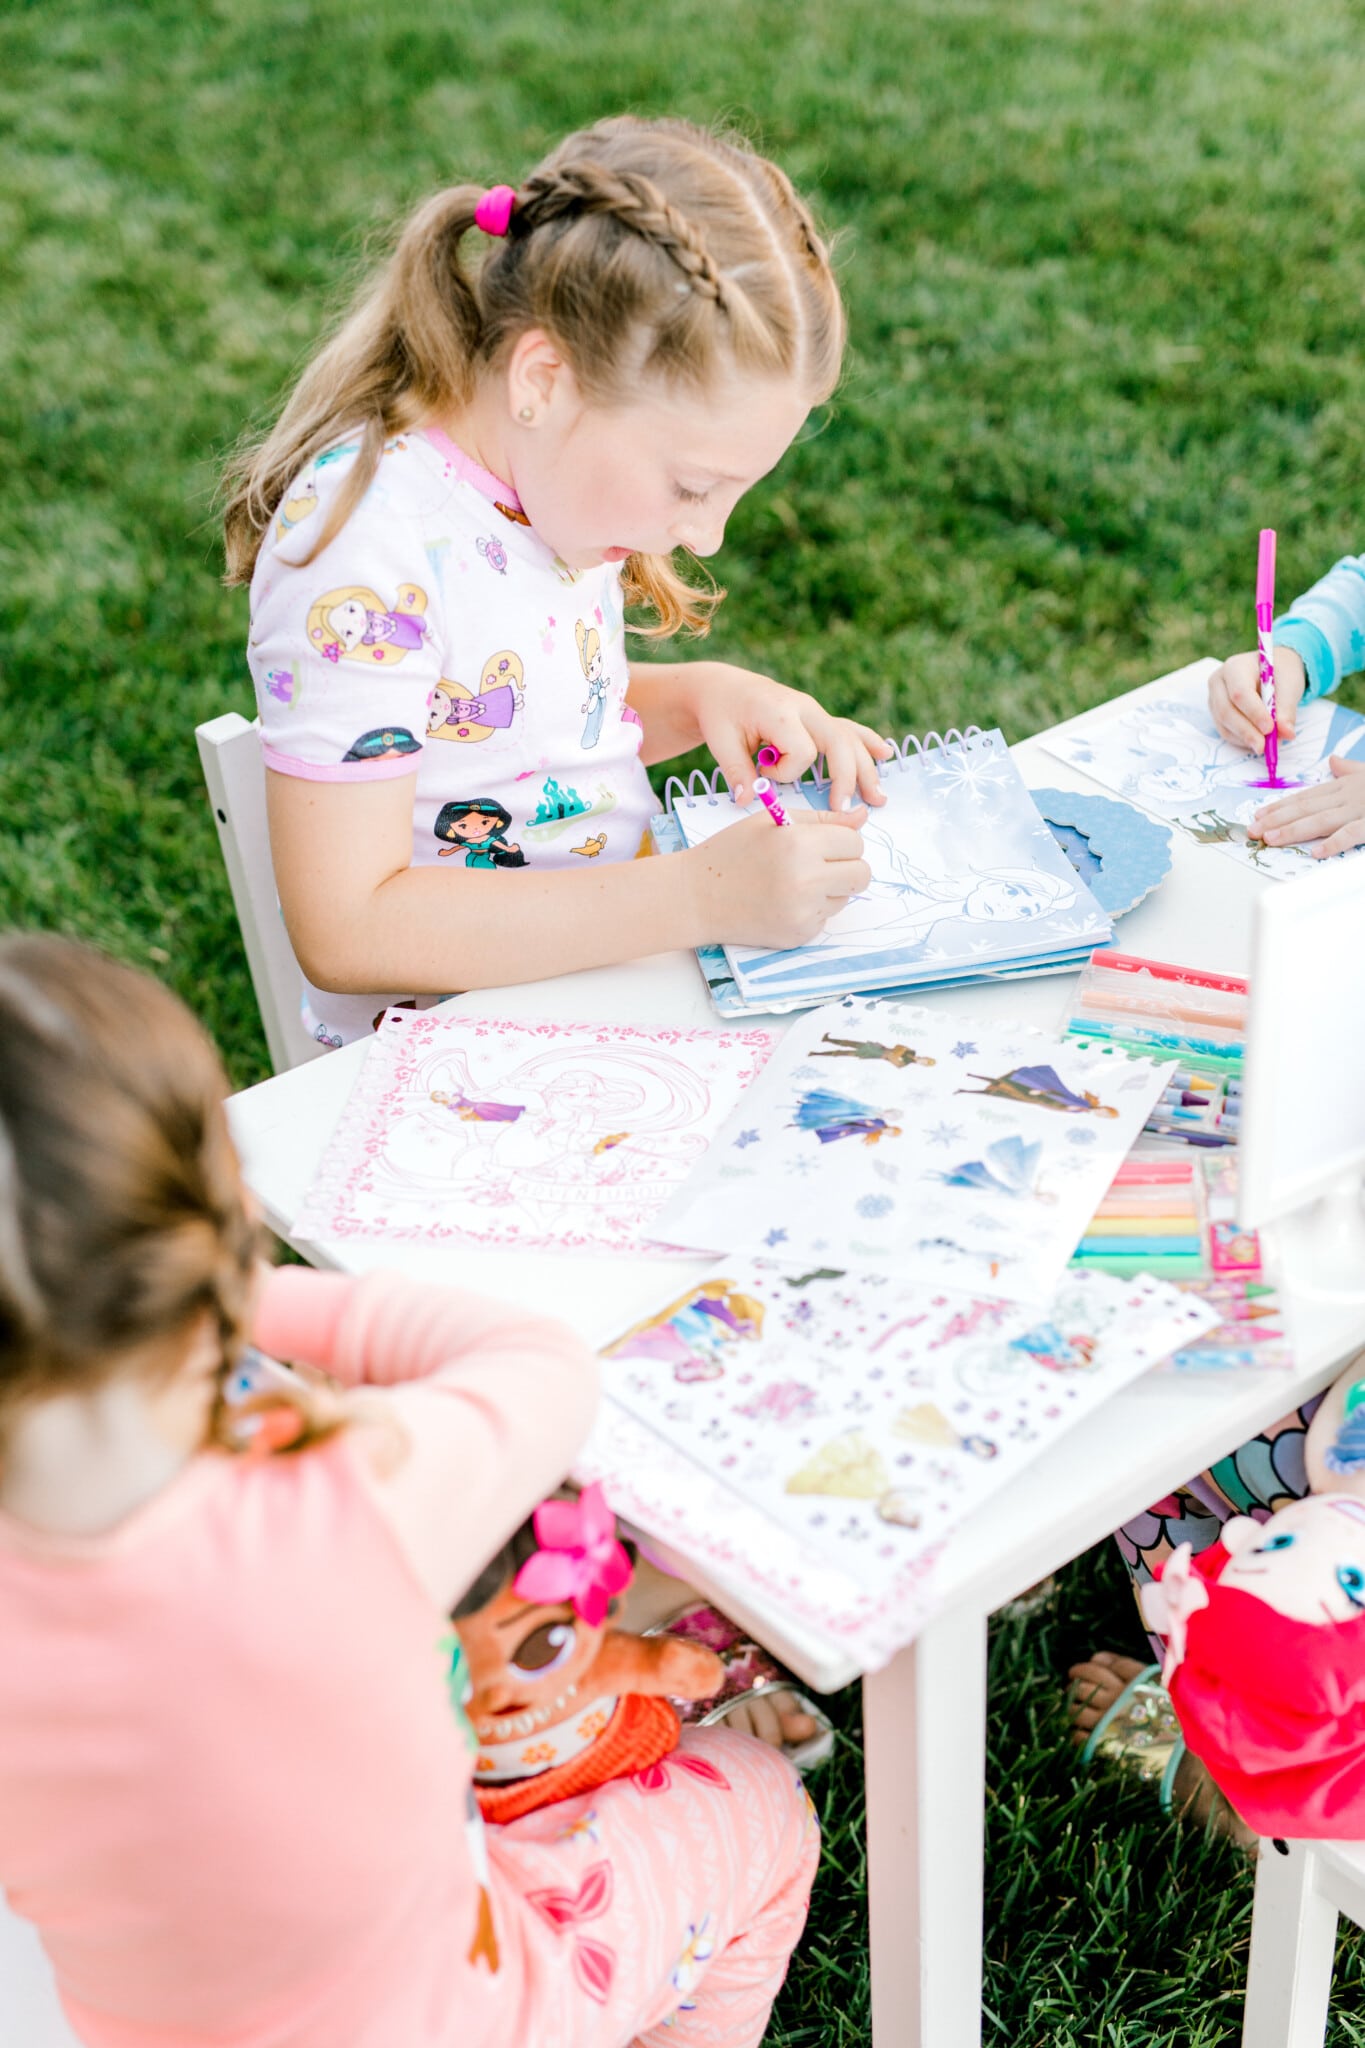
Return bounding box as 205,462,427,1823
1209,555,1365,860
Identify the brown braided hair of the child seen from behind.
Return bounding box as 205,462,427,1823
0,934,338,1456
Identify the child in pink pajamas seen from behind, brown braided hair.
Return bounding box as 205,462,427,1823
0,938,819,2048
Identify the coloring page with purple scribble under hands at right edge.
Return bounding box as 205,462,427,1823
1040,662,1365,881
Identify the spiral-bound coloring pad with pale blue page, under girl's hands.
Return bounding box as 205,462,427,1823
657,727,1111,1010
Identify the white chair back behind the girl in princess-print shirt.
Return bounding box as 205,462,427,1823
194,711,323,1073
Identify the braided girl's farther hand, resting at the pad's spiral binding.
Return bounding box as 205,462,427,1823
688,662,894,811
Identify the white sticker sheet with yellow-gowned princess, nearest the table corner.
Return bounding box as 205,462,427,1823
602,1260,1216,1595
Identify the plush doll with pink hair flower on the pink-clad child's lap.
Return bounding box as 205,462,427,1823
452,1485,724,1821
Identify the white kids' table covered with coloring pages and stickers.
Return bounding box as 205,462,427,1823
229,678,1365,2048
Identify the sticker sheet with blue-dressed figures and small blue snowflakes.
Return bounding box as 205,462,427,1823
659,997,1166,1303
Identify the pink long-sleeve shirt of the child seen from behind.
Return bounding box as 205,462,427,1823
0,1268,596,2048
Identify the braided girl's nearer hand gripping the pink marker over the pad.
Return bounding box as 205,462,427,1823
677,809,872,950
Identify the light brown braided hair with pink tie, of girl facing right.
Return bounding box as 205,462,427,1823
225,119,843,633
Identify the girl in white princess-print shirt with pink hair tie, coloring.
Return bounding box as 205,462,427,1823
227,119,888,1044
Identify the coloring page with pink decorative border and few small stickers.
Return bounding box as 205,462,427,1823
295,1010,772,1251
